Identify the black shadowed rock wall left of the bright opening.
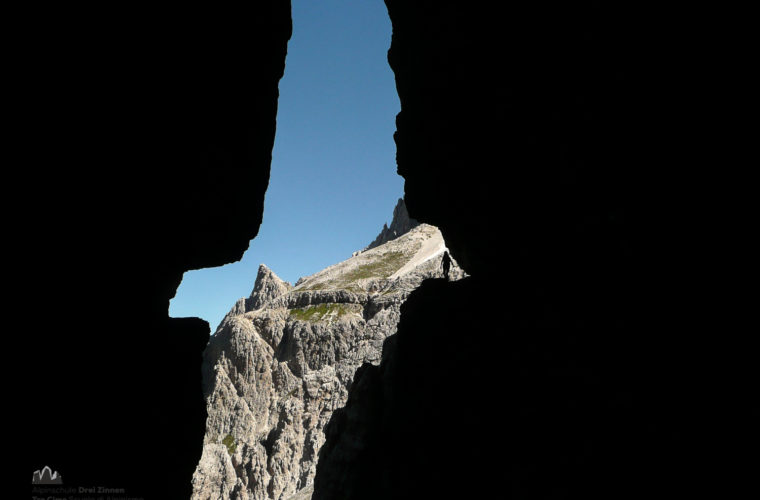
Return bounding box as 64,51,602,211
23,0,291,498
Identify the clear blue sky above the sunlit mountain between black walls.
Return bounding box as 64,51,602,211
169,0,404,333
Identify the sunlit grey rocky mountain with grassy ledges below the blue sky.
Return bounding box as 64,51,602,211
192,202,464,500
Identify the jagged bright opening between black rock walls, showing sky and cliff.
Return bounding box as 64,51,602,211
169,0,416,498
